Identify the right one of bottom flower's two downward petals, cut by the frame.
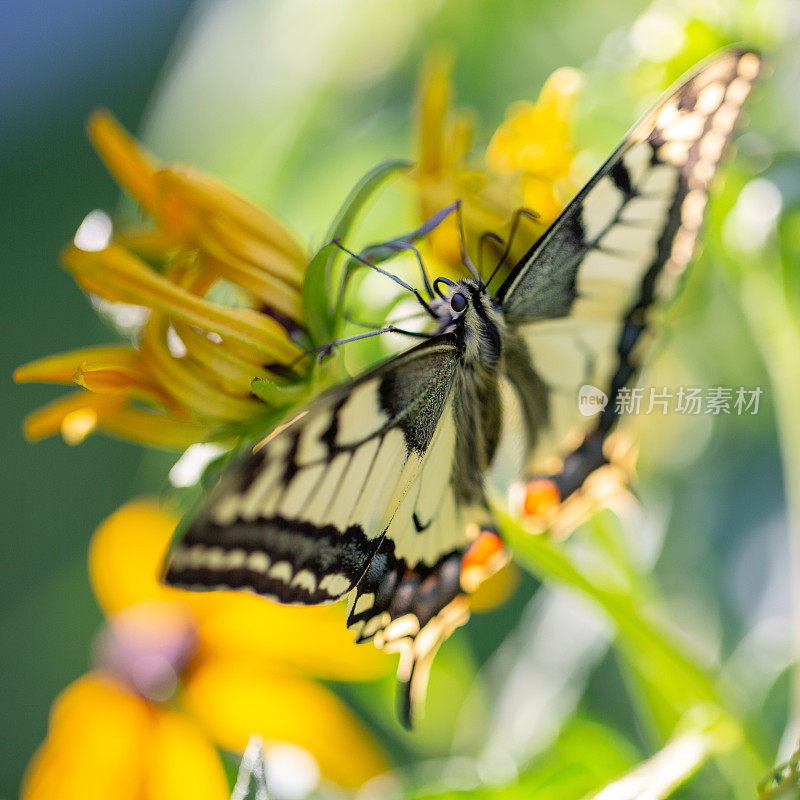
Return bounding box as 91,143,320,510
143,708,230,800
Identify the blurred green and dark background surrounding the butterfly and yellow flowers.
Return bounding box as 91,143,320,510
0,0,800,798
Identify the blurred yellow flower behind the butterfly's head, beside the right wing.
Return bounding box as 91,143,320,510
413,53,581,272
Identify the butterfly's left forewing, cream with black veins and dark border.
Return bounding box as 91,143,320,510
166,335,458,605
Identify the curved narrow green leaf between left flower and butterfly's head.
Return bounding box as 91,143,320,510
302,159,411,346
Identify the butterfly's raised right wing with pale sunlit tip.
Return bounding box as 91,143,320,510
497,50,761,468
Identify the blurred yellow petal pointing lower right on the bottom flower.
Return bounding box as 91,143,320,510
184,660,387,787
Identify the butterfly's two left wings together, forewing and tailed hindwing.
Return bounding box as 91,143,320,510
165,335,497,726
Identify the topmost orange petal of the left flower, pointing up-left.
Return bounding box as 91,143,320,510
87,109,158,213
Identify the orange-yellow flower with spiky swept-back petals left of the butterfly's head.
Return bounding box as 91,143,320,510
14,112,308,449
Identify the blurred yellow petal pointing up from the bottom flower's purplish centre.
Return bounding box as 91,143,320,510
89,499,211,616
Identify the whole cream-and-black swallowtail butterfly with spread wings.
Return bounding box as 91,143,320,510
165,49,761,726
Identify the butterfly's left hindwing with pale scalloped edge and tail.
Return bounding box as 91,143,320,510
347,370,500,727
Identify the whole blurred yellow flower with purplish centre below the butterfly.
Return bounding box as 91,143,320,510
22,500,391,800
